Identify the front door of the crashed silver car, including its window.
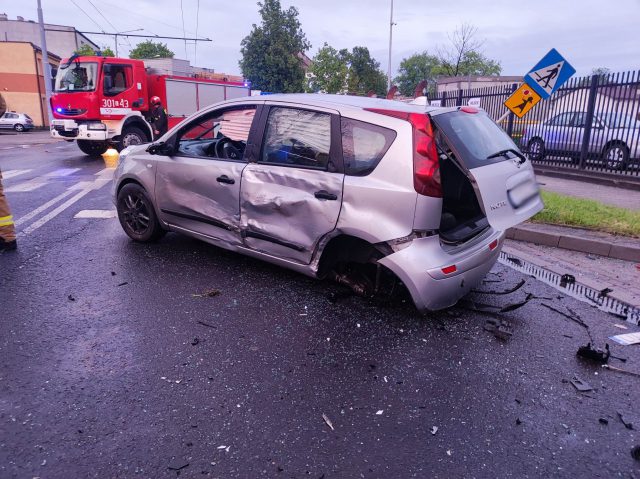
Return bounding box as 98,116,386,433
155,104,259,248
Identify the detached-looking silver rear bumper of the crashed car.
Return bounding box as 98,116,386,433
379,230,505,311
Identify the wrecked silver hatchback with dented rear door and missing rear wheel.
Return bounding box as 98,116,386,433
113,94,543,311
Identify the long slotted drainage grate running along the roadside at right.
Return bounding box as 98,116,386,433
498,251,640,326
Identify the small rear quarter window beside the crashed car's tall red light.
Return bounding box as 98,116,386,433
340,118,396,176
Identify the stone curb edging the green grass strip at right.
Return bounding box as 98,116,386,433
507,225,640,262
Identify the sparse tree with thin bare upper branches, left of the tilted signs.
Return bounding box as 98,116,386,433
438,24,502,77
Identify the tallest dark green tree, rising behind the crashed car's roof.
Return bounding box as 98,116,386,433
239,0,311,93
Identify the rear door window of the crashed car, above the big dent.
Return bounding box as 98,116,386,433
258,107,331,170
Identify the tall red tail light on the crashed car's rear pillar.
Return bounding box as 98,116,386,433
365,108,442,198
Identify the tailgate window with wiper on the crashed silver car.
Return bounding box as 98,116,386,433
433,111,519,168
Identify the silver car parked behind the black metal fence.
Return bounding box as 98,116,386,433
521,111,640,170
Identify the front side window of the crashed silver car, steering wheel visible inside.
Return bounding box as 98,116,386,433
176,105,256,161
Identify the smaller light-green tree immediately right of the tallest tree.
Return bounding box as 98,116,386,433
306,42,349,93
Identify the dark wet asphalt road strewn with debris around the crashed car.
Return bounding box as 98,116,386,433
0,137,640,479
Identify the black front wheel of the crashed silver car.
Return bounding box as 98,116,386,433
116,183,166,243
